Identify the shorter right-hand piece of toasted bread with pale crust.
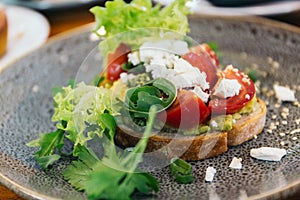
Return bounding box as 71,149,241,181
227,98,267,146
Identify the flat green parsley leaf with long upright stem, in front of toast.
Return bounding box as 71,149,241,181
63,107,159,199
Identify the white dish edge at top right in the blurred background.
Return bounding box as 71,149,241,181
156,0,300,16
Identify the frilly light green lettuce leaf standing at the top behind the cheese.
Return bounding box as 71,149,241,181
90,0,189,58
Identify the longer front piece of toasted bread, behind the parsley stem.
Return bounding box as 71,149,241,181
115,126,227,161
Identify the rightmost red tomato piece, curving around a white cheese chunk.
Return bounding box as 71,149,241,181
208,67,255,114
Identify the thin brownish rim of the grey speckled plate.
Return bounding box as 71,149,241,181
0,13,300,199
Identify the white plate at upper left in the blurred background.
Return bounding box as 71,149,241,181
0,6,50,72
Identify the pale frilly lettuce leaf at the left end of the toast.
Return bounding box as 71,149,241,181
52,83,113,146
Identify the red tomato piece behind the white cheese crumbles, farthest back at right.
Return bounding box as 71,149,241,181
182,51,218,89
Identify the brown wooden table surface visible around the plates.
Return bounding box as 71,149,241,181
0,3,300,200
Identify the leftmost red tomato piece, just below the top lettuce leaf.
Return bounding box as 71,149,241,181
106,43,131,81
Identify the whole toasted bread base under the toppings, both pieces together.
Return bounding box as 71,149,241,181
115,99,266,161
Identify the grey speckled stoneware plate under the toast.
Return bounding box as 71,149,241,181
0,15,300,200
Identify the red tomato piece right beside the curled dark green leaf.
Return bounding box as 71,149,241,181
166,90,210,129
